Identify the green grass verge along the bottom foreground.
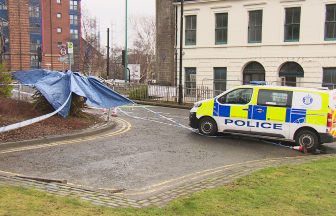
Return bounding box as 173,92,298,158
0,157,336,216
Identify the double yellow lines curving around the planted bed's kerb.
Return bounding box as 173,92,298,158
0,118,132,155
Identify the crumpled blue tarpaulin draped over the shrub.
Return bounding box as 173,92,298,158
13,69,133,118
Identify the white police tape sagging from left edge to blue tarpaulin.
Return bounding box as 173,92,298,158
0,93,72,133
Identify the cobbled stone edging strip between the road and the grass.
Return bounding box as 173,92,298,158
0,155,335,208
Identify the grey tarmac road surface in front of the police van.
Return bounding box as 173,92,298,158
0,107,336,190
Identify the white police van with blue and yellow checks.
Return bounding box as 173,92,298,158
189,85,336,151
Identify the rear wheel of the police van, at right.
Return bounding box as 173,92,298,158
295,130,320,152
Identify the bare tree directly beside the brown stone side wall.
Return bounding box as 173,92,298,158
129,16,156,82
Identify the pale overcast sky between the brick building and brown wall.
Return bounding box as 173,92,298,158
82,0,155,45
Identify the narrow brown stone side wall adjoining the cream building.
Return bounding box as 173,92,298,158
156,0,175,85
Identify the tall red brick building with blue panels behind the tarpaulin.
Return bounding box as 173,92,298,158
0,0,81,71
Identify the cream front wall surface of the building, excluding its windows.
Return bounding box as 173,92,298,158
175,0,336,88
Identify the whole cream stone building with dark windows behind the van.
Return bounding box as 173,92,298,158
176,0,336,95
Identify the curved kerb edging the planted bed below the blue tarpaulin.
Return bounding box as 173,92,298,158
0,121,117,150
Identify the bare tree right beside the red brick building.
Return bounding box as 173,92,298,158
81,9,105,76
